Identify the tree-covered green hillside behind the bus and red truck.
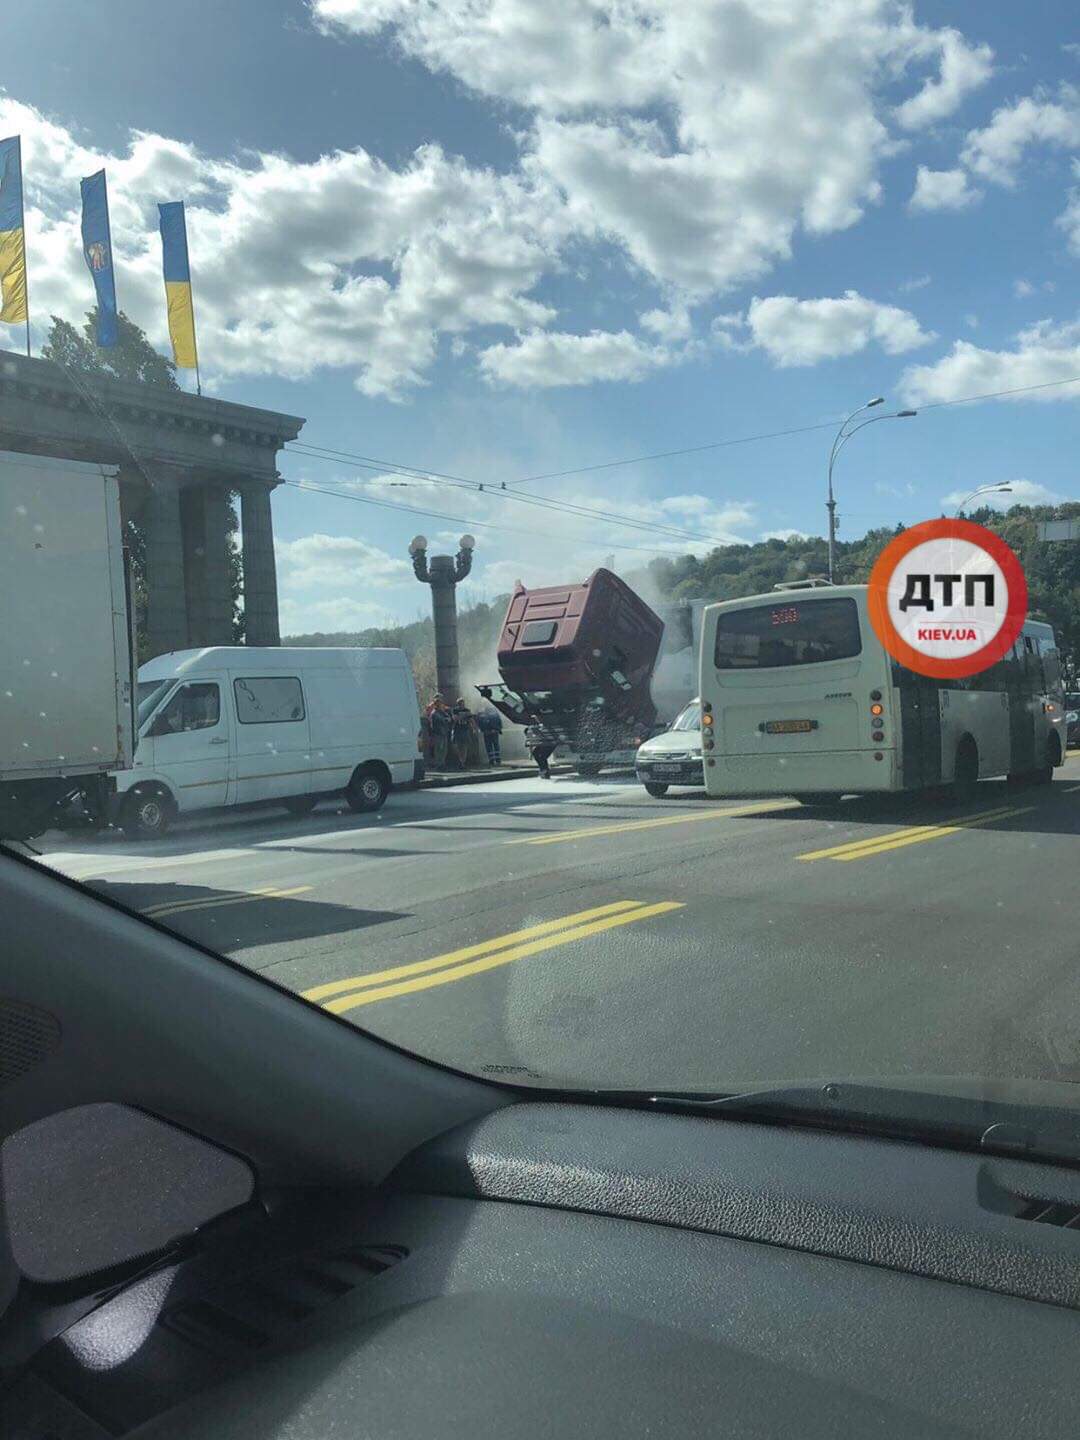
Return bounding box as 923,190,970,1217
285,504,1080,700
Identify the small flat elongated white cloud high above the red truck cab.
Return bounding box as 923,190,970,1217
480,330,677,389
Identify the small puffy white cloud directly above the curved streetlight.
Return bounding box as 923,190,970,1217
746,289,933,367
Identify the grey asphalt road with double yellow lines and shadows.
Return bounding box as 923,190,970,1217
33,756,1080,1090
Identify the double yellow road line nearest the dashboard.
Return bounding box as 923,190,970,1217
302,900,683,1015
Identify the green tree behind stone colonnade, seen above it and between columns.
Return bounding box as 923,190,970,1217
42,315,243,660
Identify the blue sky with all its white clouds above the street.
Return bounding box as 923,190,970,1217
0,0,1080,631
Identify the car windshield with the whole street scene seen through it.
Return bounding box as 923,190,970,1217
0,0,1080,1146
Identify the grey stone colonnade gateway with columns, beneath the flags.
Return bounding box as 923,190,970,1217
0,351,304,655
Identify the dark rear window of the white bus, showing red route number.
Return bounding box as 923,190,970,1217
716,596,863,670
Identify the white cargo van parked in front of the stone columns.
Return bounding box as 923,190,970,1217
115,645,423,838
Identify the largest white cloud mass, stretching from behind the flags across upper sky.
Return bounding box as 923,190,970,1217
0,0,1008,399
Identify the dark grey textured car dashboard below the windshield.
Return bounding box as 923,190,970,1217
4,1102,1080,1440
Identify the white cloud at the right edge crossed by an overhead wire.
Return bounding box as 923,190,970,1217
900,320,1080,406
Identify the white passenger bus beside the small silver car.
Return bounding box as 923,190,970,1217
700,585,1066,804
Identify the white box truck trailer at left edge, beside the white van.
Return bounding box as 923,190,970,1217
0,451,134,840
